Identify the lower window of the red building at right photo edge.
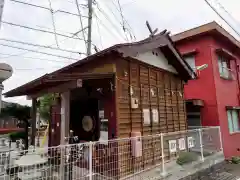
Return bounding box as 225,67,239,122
227,110,240,133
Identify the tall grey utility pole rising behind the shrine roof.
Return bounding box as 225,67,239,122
87,0,93,56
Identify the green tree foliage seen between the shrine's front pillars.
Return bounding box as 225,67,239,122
39,94,54,122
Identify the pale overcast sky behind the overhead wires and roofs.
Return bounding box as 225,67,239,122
0,0,240,105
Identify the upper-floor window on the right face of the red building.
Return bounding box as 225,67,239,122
218,55,231,79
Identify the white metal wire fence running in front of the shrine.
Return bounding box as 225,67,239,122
0,127,222,180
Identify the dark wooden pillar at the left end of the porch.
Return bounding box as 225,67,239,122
31,98,37,146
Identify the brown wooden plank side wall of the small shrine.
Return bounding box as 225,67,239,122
116,60,186,179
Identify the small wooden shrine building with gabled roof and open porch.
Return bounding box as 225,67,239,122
5,32,195,179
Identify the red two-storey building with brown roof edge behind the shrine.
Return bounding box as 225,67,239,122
172,22,240,158
